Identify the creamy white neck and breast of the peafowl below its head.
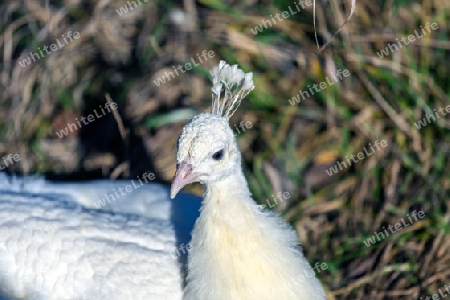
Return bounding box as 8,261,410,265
184,169,326,300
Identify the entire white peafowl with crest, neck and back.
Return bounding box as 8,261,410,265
0,62,326,300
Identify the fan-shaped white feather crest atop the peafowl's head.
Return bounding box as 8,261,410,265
209,60,255,119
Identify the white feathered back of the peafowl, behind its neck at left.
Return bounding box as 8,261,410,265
0,173,200,300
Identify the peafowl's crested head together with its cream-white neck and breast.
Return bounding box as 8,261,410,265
171,61,326,300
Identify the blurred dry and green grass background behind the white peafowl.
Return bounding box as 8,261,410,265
0,0,450,299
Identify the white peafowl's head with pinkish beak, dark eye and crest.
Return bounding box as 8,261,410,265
170,61,254,199
